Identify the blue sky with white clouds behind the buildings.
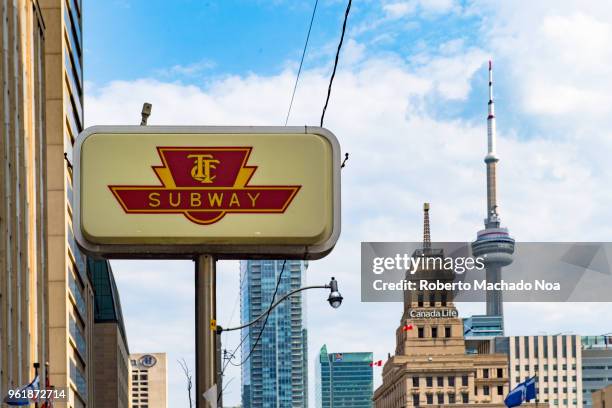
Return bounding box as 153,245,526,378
84,0,612,406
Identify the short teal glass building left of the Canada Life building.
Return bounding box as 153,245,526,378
316,345,374,408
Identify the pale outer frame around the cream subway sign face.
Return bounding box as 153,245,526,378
73,125,341,260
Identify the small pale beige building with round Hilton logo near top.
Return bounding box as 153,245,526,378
130,353,168,408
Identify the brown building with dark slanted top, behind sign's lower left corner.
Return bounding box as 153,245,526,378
87,259,130,408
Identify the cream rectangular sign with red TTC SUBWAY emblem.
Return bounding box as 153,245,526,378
74,126,340,259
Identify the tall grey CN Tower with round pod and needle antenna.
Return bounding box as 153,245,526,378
472,61,514,327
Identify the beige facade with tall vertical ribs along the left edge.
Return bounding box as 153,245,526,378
0,0,49,395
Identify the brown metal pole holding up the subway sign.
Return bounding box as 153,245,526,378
195,255,218,408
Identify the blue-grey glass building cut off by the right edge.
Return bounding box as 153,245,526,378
582,335,612,408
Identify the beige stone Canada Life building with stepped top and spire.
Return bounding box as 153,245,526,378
373,203,510,408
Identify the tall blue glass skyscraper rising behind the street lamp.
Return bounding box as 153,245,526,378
240,260,308,408
